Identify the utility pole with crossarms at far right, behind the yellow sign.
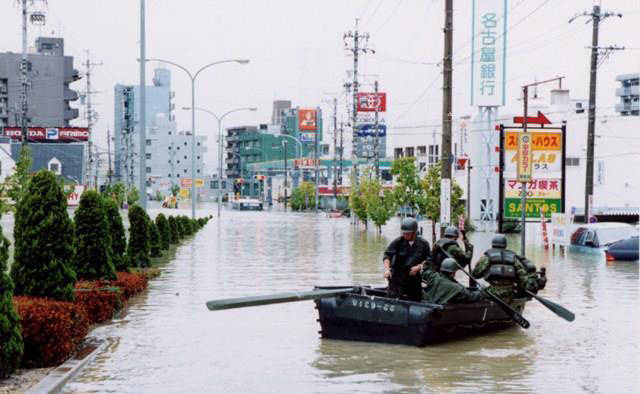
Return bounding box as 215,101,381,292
569,5,624,223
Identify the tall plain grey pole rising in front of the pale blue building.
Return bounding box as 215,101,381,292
138,0,146,211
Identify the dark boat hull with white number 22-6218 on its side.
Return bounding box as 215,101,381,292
315,287,529,346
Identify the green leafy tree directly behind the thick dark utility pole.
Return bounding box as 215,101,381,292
419,162,464,242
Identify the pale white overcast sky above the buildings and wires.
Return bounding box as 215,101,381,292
0,0,640,170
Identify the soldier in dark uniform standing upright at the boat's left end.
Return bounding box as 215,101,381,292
382,217,429,301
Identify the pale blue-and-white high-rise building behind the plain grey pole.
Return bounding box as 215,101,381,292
114,68,207,199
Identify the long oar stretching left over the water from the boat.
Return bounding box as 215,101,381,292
207,287,358,311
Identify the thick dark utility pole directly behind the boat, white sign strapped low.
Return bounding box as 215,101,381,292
440,0,453,231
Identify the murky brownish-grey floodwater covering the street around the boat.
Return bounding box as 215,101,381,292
64,207,640,393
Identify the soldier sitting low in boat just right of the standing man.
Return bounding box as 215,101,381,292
422,257,484,304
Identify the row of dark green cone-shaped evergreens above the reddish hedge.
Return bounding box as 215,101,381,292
0,170,209,379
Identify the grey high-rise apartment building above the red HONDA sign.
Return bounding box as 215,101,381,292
0,37,80,127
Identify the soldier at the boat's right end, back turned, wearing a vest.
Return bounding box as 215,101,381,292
471,234,537,303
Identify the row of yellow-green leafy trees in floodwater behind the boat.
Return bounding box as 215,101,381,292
349,157,464,237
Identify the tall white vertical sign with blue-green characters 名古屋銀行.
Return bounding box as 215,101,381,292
471,0,507,107
